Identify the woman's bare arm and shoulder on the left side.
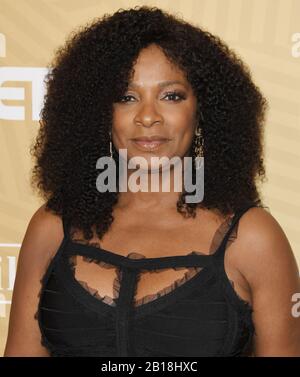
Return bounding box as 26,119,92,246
3,205,63,356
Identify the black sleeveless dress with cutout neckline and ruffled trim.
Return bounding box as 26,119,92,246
36,206,254,357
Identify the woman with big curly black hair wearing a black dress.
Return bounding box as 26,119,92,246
5,6,300,356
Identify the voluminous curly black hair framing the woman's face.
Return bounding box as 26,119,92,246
30,6,268,239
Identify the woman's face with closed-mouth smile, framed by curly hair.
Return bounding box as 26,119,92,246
112,44,197,167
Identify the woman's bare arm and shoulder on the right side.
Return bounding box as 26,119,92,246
238,208,300,356
